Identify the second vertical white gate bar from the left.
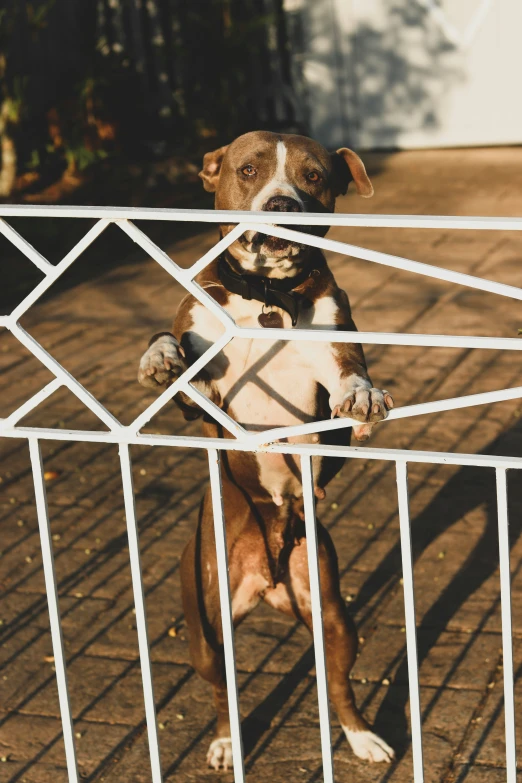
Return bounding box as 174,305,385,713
119,443,162,783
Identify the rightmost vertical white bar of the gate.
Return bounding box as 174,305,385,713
495,468,517,783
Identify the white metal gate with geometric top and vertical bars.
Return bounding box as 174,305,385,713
0,205,522,783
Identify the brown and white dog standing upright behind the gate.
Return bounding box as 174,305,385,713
138,131,394,769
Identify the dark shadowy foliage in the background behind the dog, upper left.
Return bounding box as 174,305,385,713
0,0,293,201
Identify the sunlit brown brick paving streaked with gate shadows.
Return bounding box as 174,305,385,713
0,149,522,783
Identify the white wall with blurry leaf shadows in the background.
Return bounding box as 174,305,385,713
285,0,522,148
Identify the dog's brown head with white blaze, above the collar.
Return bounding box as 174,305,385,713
199,131,373,277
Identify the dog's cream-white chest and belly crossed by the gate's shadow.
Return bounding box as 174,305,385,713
190,296,336,505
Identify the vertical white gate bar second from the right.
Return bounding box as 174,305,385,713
395,460,424,783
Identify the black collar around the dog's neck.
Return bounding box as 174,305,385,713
217,255,313,326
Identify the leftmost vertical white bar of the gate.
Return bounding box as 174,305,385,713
29,438,79,783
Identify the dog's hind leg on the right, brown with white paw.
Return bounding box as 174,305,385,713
264,525,395,762
